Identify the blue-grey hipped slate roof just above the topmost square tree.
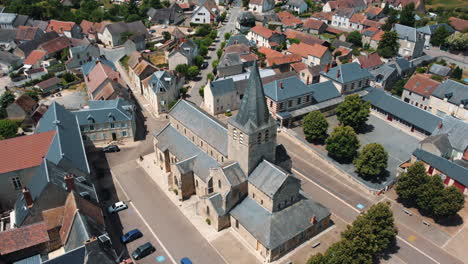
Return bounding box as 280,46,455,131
320,62,373,83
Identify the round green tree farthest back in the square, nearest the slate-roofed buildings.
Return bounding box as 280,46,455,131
336,94,370,130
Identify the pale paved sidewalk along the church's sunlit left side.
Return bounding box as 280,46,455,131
137,153,228,242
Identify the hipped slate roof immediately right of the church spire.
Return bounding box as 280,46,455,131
263,76,312,102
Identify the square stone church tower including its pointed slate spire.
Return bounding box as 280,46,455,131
228,63,276,175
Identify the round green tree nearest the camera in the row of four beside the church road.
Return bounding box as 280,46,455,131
353,143,388,179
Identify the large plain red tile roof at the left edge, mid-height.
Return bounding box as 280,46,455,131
0,130,55,173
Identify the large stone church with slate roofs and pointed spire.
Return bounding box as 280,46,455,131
154,64,331,262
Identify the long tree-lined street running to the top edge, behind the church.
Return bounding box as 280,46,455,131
187,7,241,106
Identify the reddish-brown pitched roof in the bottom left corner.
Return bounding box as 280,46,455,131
0,222,50,256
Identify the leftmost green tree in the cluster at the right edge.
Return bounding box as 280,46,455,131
395,162,429,203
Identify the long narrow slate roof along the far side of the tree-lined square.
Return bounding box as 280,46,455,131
362,88,442,133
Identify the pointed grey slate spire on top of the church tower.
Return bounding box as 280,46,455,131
229,62,274,133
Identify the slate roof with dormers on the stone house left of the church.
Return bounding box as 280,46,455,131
72,98,134,125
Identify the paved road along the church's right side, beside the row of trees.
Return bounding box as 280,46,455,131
278,135,463,264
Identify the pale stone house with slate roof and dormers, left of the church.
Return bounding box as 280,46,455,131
72,98,136,145
